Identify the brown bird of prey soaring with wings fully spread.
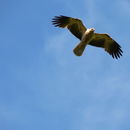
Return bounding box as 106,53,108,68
52,15,123,59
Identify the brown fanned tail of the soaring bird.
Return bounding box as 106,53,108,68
73,42,87,56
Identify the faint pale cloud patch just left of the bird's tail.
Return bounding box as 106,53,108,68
43,30,71,62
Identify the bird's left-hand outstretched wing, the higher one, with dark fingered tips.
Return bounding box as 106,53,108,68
52,15,86,40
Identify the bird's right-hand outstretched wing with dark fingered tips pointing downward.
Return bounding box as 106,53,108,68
89,33,123,59
